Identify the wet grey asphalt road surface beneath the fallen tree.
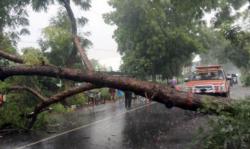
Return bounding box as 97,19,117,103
0,87,250,149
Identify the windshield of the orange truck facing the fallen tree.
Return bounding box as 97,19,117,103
191,70,225,80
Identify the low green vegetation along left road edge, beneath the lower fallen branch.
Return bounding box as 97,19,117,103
0,88,111,131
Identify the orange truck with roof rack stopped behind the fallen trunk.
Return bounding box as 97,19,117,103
185,65,230,97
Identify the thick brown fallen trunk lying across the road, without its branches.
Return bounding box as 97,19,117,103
0,66,232,112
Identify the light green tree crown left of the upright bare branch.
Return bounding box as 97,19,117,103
39,10,91,67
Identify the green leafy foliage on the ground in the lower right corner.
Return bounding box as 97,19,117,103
200,98,250,149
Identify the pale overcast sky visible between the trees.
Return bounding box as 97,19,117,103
18,0,121,70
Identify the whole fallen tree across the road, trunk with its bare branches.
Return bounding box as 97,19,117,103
0,0,233,128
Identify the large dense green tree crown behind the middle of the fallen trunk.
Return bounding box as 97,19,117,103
105,0,209,78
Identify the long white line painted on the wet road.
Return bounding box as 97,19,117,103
16,102,155,149
